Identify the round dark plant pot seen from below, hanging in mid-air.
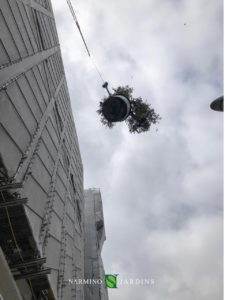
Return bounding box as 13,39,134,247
102,95,131,122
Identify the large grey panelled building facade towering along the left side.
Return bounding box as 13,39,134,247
0,0,84,300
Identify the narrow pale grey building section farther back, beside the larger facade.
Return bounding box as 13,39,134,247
84,189,108,300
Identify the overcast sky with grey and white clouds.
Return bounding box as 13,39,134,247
52,0,223,300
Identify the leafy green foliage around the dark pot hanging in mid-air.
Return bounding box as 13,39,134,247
97,85,161,133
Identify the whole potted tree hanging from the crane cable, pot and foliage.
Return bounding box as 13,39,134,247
97,82,161,133
